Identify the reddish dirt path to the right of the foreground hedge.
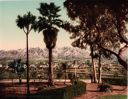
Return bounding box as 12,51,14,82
74,83,128,99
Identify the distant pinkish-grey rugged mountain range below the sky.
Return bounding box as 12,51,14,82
0,47,90,59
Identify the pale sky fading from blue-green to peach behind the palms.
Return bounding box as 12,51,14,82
0,0,72,50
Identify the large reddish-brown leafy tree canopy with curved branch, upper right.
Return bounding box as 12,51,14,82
64,0,128,69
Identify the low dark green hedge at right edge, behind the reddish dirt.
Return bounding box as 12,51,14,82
102,77,127,86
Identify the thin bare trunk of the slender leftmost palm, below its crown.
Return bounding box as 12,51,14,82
26,34,30,95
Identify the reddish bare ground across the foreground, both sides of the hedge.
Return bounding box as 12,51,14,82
0,82,128,99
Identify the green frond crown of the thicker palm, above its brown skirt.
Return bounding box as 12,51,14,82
34,3,63,32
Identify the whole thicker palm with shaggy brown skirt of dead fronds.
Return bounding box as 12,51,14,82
35,3,62,86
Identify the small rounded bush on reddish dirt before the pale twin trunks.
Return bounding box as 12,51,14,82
98,83,113,92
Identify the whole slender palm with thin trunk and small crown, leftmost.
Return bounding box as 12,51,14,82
16,12,36,94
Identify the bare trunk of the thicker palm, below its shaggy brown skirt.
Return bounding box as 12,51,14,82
48,48,54,86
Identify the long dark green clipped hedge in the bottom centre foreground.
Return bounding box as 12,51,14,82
30,82,86,99
